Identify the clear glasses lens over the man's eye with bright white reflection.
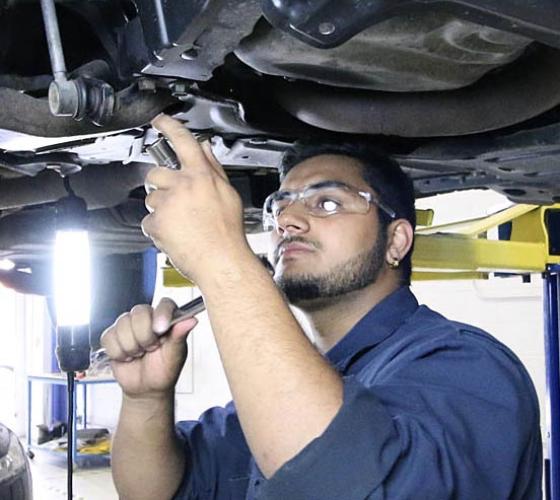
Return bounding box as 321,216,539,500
302,186,369,217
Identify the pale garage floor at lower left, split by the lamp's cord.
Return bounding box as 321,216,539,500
30,452,119,500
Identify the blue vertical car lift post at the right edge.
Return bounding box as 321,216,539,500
543,264,560,500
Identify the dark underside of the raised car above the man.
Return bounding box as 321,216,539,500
0,0,560,293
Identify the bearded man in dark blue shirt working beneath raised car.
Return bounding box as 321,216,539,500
102,115,542,500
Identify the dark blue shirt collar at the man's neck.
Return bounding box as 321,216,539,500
326,286,418,372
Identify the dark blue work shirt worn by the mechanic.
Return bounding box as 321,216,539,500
176,288,542,500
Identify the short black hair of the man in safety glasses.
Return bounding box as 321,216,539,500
279,142,416,284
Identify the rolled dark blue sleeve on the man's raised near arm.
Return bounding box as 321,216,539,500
259,332,542,500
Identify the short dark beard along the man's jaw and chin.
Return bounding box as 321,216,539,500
275,228,387,307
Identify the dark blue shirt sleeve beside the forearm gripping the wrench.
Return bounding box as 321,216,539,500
173,403,251,500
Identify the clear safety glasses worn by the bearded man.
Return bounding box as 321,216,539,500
263,181,396,229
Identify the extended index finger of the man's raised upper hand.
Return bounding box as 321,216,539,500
152,114,213,176
